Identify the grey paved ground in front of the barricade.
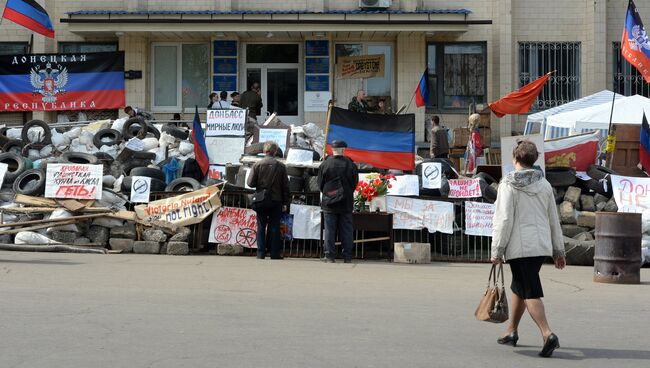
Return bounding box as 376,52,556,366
0,252,650,368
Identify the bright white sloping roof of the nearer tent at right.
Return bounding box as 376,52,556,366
546,95,650,131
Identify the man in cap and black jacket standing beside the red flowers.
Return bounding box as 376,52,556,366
318,140,359,263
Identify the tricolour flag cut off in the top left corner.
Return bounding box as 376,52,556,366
2,0,54,38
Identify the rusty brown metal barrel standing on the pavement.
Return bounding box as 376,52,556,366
594,212,641,284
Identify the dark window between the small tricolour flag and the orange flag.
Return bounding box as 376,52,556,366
427,43,487,109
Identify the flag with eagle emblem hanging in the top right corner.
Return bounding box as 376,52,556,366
621,0,650,83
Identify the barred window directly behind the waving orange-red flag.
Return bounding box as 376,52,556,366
519,42,580,111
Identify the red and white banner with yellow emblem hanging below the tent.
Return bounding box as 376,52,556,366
544,131,600,171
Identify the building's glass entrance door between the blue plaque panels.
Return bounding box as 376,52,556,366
242,44,303,124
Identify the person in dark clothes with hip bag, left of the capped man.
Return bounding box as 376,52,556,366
247,141,290,259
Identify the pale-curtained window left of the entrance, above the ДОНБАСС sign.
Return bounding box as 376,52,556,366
152,43,210,112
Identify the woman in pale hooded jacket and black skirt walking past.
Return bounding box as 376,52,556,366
492,140,565,357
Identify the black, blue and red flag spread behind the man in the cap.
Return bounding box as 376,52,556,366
327,107,415,170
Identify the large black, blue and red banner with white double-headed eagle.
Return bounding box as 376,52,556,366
0,51,125,112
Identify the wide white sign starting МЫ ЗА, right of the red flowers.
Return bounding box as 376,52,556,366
386,196,454,234
